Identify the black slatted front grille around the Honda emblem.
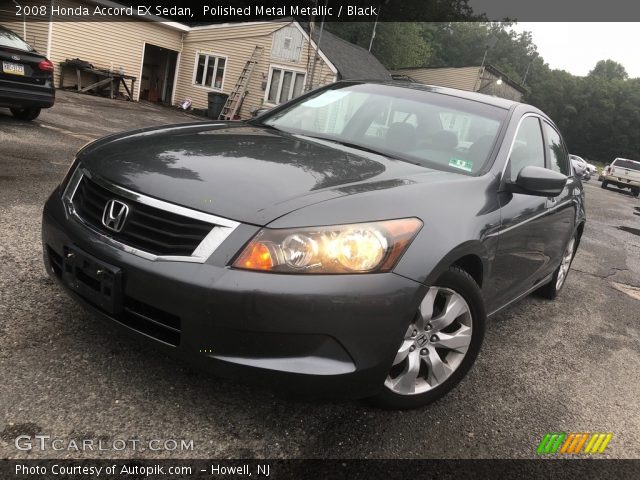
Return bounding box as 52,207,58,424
72,175,215,256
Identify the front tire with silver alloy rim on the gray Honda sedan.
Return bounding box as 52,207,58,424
371,266,486,410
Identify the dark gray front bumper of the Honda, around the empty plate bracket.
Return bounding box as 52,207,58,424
42,191,426,398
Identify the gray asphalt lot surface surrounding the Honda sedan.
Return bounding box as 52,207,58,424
0,92,640,458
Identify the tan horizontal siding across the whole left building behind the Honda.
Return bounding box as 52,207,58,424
0,10,336,118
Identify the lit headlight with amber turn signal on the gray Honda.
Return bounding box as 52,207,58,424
232,218,422,274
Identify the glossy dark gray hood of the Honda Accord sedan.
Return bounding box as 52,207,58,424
78,122,442,225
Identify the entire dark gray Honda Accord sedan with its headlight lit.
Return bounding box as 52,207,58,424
43,81,585,408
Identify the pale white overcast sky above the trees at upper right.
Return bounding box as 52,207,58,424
513,22,640,78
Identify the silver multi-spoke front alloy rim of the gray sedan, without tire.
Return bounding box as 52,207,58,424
384,287,473,395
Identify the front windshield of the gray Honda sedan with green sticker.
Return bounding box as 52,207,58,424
261,84,507,175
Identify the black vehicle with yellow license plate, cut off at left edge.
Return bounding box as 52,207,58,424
0,26,56,120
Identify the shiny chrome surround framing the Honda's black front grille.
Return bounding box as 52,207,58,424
62,167,240,263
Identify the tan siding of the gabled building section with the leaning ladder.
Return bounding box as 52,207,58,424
175,22,335,118
